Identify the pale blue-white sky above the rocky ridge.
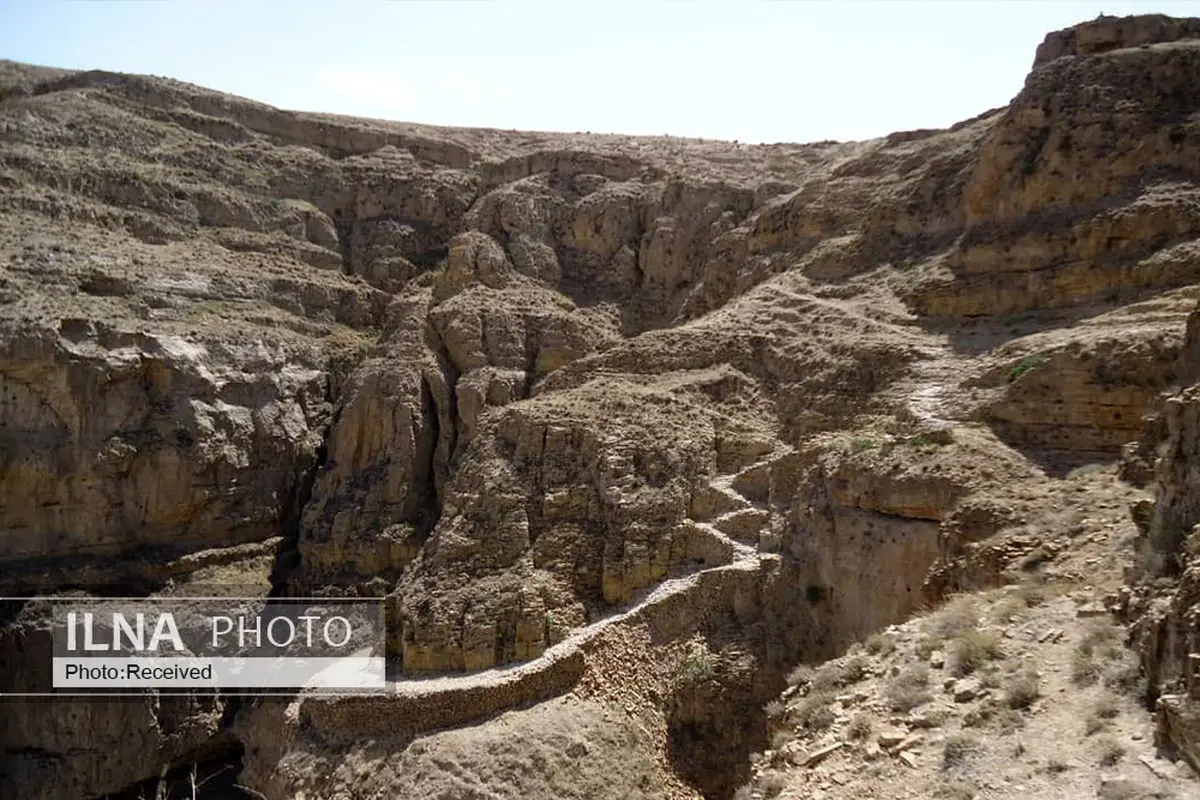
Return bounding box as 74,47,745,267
0,0,1200,143
